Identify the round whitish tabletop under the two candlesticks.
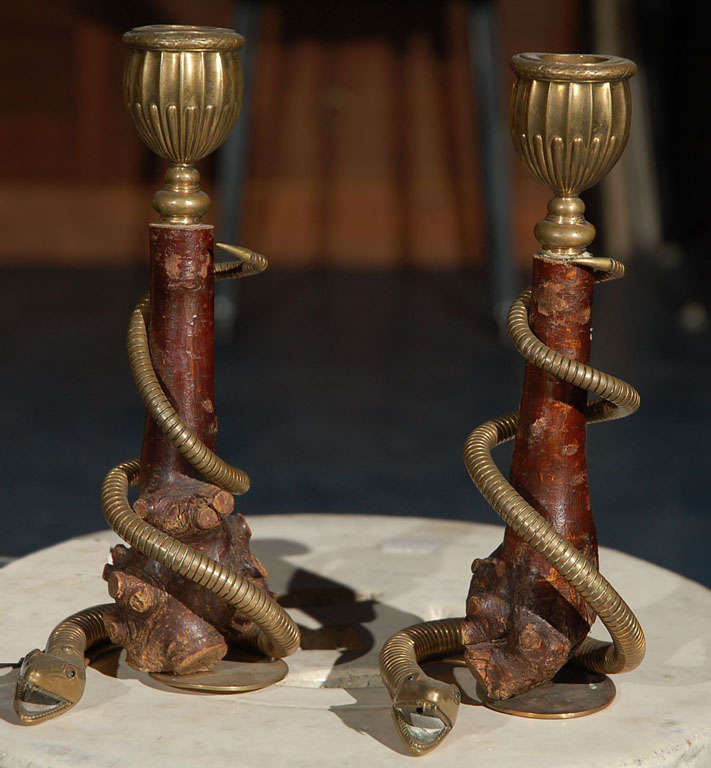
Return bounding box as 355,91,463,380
0,515,711,768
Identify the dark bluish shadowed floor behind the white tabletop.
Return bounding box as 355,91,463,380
0,261,711,585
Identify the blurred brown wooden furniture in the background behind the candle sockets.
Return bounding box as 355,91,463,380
0,0,579,269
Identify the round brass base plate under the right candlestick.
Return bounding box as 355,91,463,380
477,666,615,720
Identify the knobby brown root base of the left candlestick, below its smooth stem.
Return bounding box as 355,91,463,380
103,478,267,675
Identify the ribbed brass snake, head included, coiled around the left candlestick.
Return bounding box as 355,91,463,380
14,243,300,725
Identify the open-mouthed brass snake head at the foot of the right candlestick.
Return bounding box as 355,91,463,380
393,675,462,755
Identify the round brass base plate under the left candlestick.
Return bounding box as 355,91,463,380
150,659,289,693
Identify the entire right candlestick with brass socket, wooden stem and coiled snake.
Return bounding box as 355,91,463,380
381,53,645,754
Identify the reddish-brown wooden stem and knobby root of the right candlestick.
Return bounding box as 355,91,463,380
465,257,597,698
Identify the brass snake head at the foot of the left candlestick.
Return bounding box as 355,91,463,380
13,650,86,725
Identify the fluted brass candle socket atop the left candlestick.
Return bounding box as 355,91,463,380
123,25,244,224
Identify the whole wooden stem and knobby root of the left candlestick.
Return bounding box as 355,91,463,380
99,224,267,674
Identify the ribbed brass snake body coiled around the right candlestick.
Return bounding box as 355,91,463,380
380,255,646,754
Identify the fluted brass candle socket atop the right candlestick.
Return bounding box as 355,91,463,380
511,53,637,258
